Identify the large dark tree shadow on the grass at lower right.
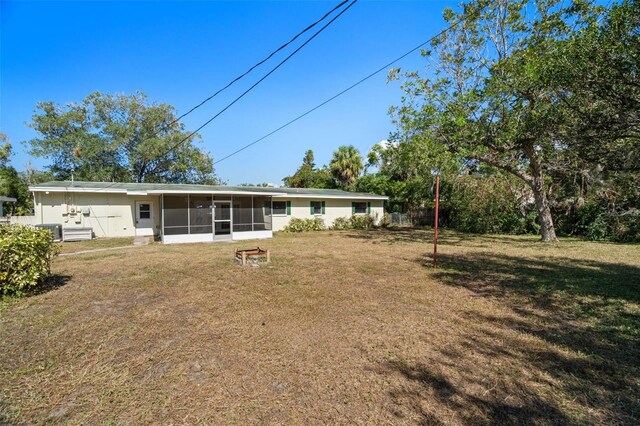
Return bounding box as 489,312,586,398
390,253,640,424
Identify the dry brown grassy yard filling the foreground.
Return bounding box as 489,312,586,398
0,229,640,424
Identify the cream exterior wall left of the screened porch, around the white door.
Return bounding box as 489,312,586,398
34,192,160,238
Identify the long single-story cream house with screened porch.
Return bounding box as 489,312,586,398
18,181,388,243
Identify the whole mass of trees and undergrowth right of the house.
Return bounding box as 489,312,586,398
286,0,640,241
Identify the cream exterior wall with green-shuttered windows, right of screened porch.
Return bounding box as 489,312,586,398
273,197,384,231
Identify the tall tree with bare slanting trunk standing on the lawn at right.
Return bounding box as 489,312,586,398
393,0,616,241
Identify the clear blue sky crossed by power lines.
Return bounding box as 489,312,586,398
0,0,455,184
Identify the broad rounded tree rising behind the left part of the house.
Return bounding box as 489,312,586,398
27,92,218,184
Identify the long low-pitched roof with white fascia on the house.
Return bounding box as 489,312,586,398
29,181,389,200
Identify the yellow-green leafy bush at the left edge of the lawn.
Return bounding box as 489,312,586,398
0,225,59,295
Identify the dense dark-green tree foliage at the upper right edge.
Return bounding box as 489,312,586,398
539,0,640,172
